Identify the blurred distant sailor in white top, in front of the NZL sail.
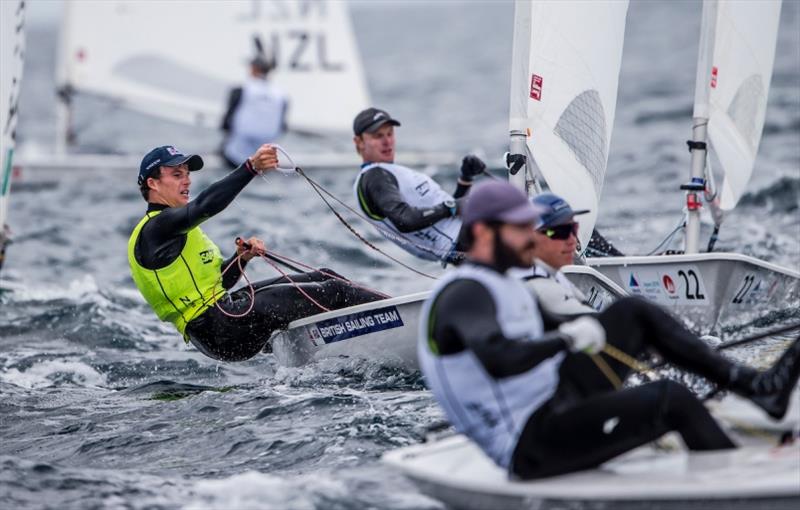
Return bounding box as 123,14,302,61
222,54,289,168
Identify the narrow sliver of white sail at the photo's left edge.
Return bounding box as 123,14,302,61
0,0,25,231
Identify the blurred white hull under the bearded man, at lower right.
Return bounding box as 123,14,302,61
383,391,800,510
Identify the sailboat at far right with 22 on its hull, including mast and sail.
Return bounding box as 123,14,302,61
580,0,800,333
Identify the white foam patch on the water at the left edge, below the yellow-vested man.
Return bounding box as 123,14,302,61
0,360,108,389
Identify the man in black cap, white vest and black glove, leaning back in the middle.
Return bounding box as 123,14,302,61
353,108,486,262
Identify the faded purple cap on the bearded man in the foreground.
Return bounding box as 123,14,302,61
461,181,539,225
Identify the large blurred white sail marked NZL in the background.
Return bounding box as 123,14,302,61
57,0,369,133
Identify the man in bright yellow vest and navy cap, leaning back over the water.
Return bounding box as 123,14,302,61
128,145,382,361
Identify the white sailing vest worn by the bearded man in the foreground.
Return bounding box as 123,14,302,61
417,264,564,468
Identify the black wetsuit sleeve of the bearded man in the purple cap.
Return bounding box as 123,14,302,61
431,279,567,379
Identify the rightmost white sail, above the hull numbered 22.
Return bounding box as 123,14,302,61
695,0,781,210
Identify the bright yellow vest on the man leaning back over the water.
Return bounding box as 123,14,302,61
128,211,225,339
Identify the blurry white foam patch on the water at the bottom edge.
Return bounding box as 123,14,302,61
182,471,349,510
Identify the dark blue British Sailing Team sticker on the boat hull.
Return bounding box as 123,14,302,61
311,306,403,345
